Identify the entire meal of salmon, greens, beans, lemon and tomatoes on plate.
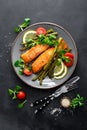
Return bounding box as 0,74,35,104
14,27,74,85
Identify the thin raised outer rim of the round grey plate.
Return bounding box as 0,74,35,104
11,22,78,90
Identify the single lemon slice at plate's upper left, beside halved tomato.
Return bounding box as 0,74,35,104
23,30,36,43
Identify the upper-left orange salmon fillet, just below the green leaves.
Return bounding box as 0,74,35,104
20,44,49,63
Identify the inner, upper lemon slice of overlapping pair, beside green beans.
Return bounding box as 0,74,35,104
54,59,64,76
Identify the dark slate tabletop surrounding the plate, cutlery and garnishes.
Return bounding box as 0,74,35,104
0,0,87,130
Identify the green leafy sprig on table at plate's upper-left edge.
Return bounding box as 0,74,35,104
14,18,31,33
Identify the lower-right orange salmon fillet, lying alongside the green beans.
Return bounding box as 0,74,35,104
32,48,54,73
